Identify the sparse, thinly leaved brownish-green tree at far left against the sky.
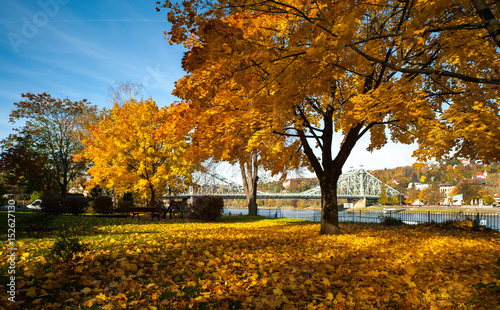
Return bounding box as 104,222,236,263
4,93,95,196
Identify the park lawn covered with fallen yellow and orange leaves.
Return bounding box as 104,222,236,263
0,217,500,309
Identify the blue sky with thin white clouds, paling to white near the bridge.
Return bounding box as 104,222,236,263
0,0,414,177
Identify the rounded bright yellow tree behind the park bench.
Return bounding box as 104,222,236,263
79,99,192,201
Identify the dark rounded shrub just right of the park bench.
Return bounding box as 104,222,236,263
186,196,224,221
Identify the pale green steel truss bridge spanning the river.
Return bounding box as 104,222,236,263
176,169,403,199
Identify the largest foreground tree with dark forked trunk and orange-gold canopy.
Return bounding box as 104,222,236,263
159,0,500,234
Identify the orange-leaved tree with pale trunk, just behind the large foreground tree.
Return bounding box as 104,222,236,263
174,85,304,215
